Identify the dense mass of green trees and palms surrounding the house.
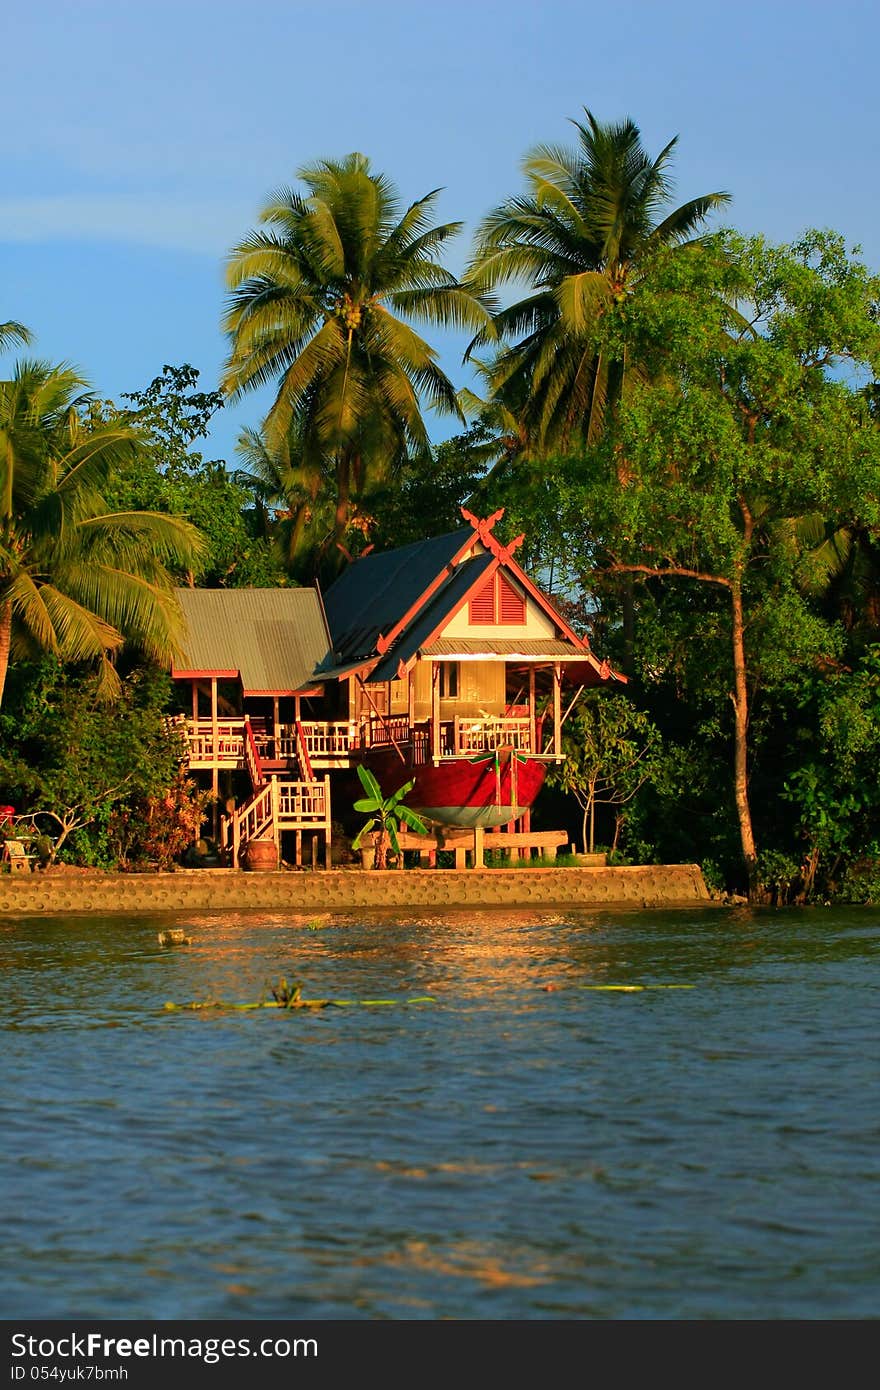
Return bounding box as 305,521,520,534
0,111,880,902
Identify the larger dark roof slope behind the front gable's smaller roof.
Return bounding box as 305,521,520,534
324,527,474,662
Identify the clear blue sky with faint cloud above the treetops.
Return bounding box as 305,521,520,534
0,0,880,460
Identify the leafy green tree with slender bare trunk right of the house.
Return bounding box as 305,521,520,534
573,232,880,891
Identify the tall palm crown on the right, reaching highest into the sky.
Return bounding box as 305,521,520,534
468,110,730,455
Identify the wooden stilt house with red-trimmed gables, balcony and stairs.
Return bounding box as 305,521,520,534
172,512,624,863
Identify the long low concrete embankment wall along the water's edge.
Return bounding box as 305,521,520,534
0,865,710,916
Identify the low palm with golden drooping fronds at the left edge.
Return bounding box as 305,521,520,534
0,361,203,701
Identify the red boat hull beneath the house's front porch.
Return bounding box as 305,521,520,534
368,749,546,830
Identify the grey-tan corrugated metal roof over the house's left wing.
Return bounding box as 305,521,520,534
172,588,328,695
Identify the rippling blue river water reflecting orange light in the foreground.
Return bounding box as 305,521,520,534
0,908,880,1319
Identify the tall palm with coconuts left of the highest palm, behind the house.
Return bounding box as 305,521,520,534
222,154,491,564
